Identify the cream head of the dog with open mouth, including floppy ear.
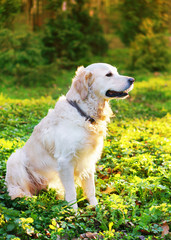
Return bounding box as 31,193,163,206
66,63,134,100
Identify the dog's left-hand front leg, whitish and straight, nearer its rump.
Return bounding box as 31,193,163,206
59,162,78,209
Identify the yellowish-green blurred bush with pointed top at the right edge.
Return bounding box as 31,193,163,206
128,19,170,72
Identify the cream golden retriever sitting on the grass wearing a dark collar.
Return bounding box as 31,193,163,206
6,63,134,208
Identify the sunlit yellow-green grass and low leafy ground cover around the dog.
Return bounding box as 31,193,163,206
0,73,171,240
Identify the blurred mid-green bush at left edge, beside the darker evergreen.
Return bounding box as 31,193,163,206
0,28,55,86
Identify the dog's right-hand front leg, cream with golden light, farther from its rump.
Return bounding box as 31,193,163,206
81,173,98,206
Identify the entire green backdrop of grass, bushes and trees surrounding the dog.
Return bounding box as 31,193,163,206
0,0,171,240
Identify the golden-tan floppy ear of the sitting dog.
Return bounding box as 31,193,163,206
74,66,93,100
